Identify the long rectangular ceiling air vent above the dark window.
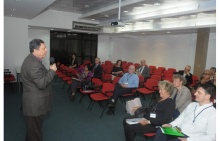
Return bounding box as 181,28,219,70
73,22,101,31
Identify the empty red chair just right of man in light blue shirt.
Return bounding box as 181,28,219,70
137,78,158,104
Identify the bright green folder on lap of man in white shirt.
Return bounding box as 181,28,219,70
160,127,188,138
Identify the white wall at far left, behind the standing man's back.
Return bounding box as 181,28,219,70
4,17,29,80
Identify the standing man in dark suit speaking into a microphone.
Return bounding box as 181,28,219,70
21,39,57,141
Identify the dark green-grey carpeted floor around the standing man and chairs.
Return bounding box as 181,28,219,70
4,80,155,141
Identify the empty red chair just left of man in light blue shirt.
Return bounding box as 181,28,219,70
88,82,115,118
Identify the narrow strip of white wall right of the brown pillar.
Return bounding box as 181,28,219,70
206,33,216,69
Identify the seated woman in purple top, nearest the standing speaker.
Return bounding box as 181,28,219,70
70,64,92,100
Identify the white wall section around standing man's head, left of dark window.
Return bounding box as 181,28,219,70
28,29,50,69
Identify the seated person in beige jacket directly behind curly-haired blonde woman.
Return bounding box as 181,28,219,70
172,74,192,119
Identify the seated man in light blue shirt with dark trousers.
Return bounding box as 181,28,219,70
107,65,139,114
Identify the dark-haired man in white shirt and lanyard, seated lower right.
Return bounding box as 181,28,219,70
154,83,216,141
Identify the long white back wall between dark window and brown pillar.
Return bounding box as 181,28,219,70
98,34,196,72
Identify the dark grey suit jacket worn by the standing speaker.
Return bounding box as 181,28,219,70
21,54,55,116
